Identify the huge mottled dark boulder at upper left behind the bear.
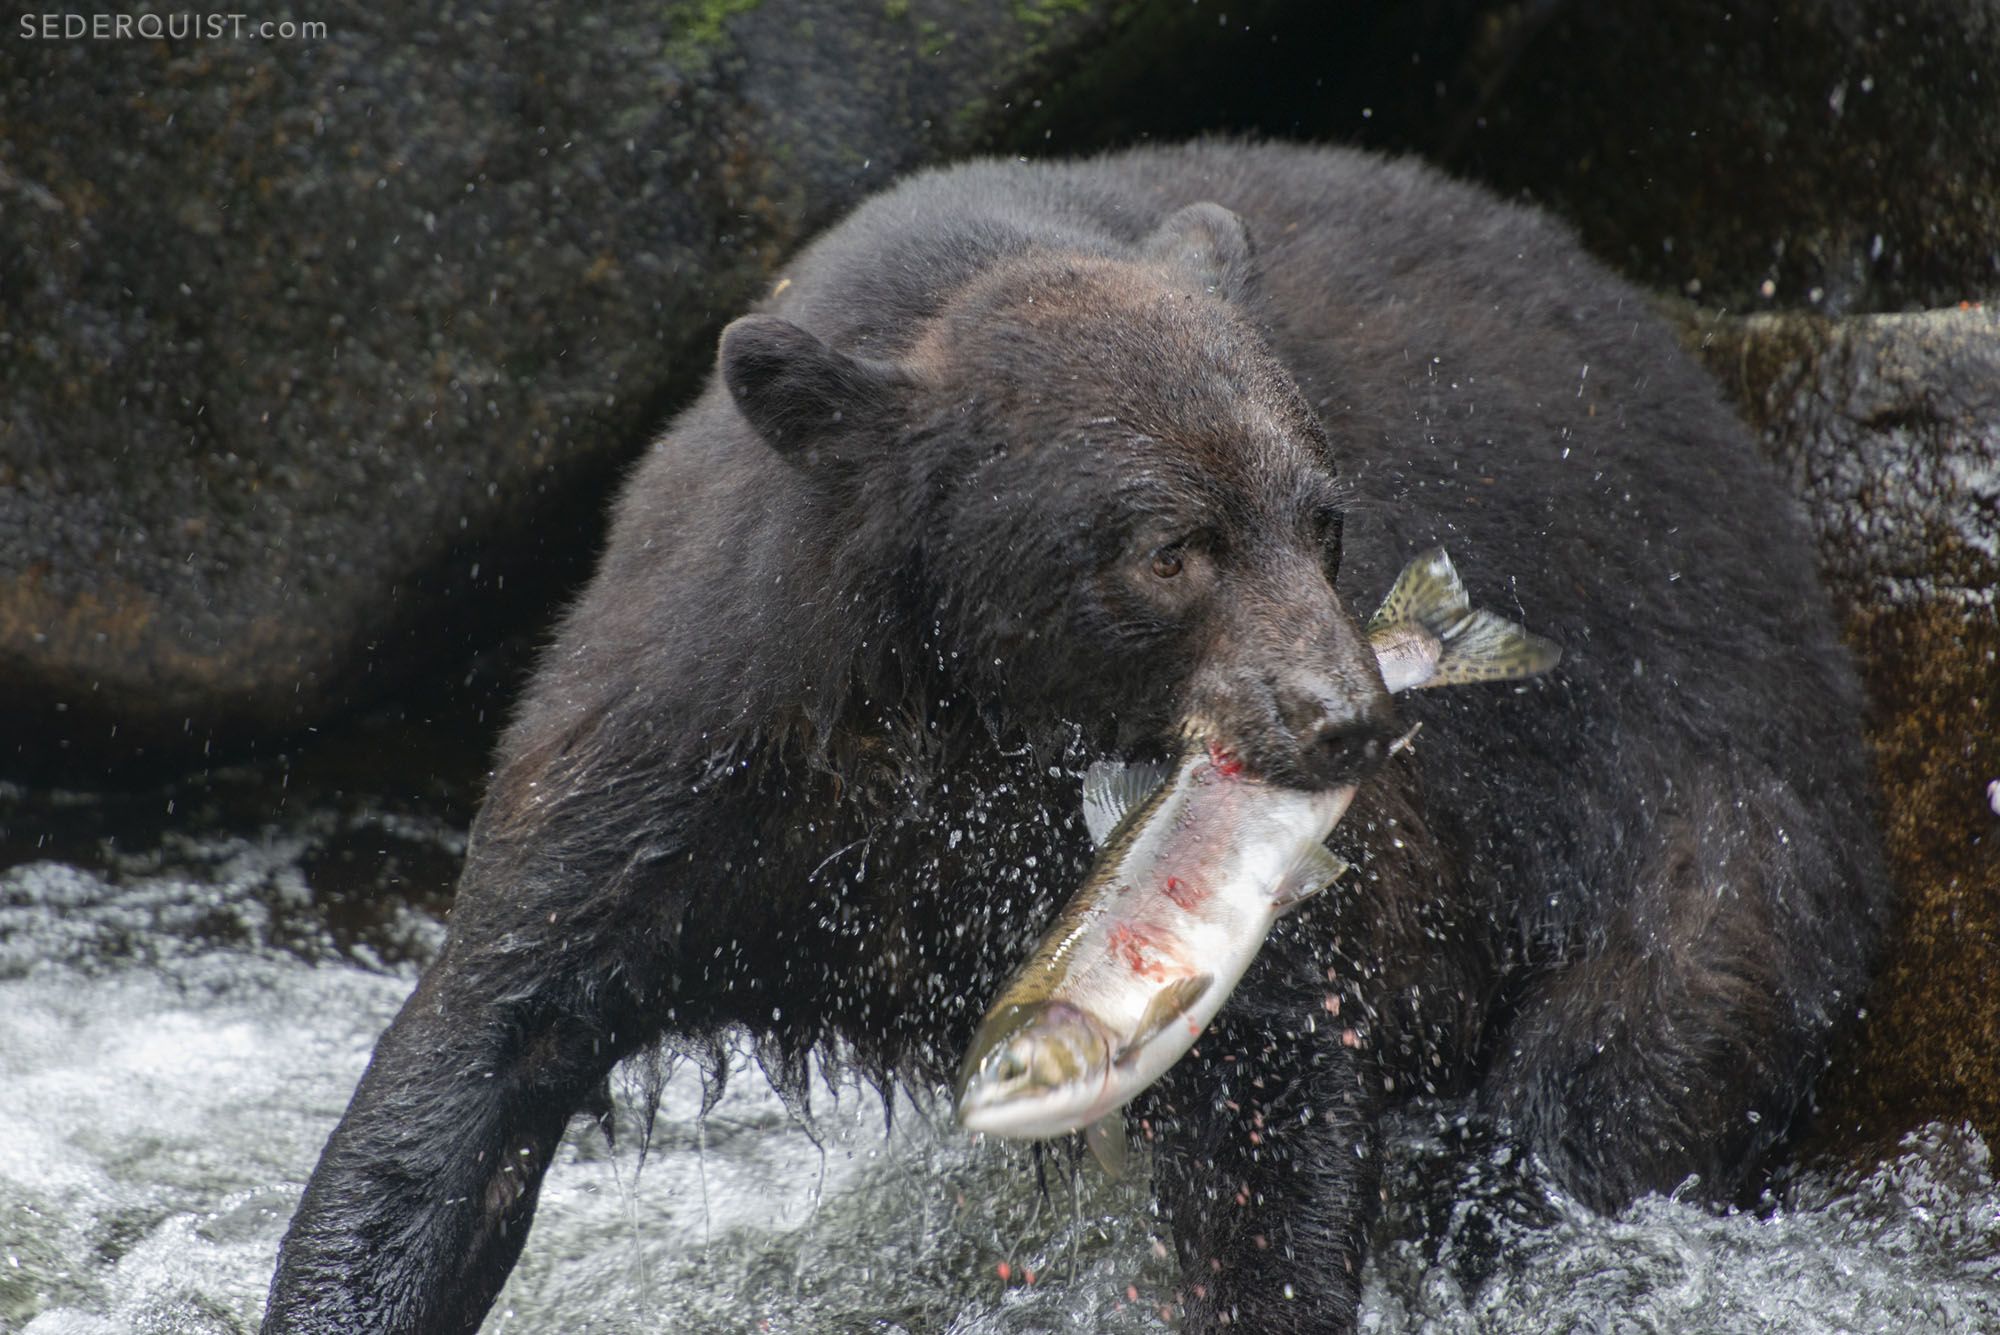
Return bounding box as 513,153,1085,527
0,0,1272,781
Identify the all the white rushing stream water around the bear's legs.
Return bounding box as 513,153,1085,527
0,775,2000,1335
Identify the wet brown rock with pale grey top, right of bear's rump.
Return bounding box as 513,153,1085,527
1688,308,2000,1149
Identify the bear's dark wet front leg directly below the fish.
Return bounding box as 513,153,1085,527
1142,975,1380,1335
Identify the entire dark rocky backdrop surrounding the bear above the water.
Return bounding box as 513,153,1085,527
0,0,2000,1153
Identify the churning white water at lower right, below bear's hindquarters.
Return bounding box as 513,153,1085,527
1362,1121,2000,1335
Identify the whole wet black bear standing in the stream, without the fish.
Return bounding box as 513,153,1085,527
264,144,1886,1331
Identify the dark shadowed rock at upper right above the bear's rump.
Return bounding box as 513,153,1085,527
1424,0,2000,314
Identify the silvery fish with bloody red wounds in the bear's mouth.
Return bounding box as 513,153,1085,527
956,548,1560,1169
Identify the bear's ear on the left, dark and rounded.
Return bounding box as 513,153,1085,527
720,316,906,460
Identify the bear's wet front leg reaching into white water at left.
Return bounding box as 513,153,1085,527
264,739,712,1335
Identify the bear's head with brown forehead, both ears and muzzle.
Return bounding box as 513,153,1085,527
720,204,1394,787
